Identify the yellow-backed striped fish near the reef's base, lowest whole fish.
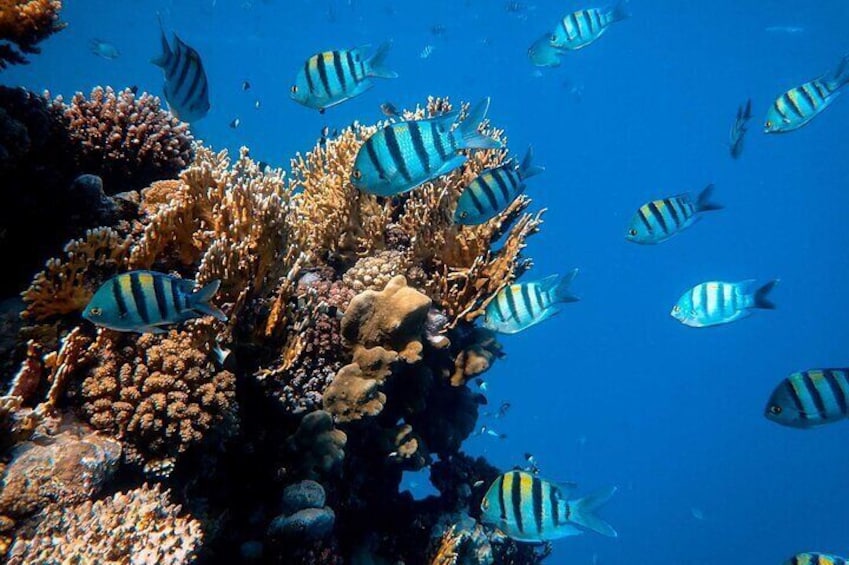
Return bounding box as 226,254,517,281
481,471,617,543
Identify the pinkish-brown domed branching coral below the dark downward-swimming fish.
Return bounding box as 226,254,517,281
54,87,192,194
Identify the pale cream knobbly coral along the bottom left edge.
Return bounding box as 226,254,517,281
9,484,203,565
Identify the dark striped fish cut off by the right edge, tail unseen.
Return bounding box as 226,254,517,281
764,369,849,428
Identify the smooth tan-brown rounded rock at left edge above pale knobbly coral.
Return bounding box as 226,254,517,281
0,420,121,518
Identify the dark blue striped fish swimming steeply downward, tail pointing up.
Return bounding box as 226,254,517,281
151,20,209,122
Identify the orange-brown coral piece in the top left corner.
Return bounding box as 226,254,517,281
0,0,67,69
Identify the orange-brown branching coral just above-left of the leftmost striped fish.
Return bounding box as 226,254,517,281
21,228,130,321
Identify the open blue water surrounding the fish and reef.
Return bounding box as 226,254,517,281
3,0,849,565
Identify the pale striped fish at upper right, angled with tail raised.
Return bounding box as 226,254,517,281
764,55,849,133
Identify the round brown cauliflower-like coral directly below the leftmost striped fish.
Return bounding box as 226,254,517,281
76,322,236,471
